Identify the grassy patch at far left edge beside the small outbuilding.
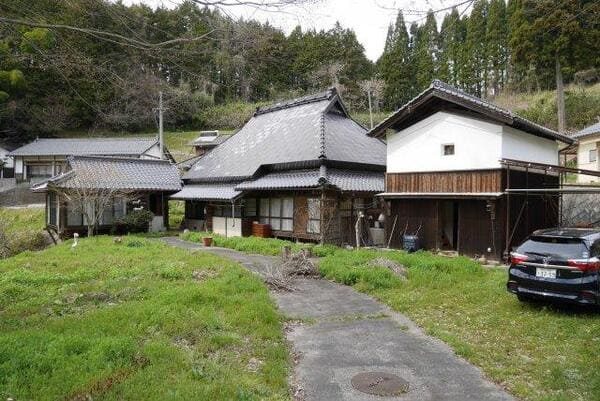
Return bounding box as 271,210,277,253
0,207,46,258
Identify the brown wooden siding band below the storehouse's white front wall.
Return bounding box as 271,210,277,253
385,170,503,192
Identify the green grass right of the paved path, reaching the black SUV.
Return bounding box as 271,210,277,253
320,250,600,401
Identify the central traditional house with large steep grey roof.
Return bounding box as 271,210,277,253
171,89,385,244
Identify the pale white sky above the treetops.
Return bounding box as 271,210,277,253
124,0,468,61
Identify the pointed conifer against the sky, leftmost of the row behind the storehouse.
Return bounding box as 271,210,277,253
377,11,413,109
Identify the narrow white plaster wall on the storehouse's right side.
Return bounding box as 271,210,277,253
502,126,558,165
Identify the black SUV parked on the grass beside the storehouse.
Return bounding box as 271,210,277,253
506,228,600,305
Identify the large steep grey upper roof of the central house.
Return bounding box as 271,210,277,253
183,89,386,182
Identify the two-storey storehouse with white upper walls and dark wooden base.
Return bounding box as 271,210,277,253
369,81,573,259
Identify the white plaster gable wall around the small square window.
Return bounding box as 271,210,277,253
387,112,502,173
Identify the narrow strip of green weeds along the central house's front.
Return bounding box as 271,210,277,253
180,231,338,256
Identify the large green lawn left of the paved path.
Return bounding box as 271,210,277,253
0,236,289,401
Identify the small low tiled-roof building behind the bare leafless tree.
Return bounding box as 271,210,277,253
32,156,181,235
